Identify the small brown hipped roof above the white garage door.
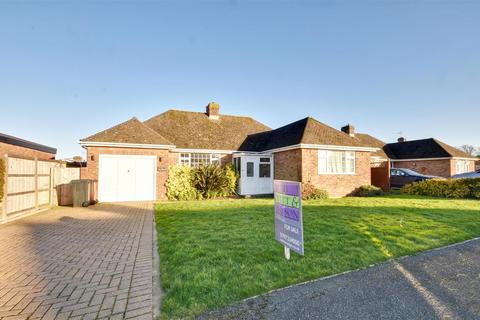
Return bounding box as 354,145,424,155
81,118,172,145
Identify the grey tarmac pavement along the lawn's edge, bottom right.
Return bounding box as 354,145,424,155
199,239,480,320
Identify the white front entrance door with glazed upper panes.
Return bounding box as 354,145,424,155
239,156,273,195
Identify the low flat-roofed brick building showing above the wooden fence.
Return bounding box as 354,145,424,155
0,133,57,160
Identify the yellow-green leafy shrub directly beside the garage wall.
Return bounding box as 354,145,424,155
167,165,201,200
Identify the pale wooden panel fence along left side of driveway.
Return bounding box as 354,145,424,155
0,156,80,223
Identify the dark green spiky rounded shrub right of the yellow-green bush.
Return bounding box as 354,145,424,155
193,164,236,199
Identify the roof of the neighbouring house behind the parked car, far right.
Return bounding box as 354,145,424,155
385,138,472,160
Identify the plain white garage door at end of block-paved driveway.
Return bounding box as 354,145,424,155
98,154,157,202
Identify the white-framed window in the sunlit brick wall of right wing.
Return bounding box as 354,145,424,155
318,150,355,174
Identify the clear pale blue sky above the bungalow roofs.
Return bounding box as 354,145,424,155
0,1,480,157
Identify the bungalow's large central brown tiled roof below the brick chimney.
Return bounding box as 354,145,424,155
145,110,270,150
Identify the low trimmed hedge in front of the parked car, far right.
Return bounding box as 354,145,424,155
401,178,480,199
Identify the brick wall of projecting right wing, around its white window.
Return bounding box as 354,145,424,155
274,149,371,197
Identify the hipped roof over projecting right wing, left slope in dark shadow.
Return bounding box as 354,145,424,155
240,117,369,151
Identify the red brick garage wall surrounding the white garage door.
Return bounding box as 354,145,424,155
81,147,180,200
